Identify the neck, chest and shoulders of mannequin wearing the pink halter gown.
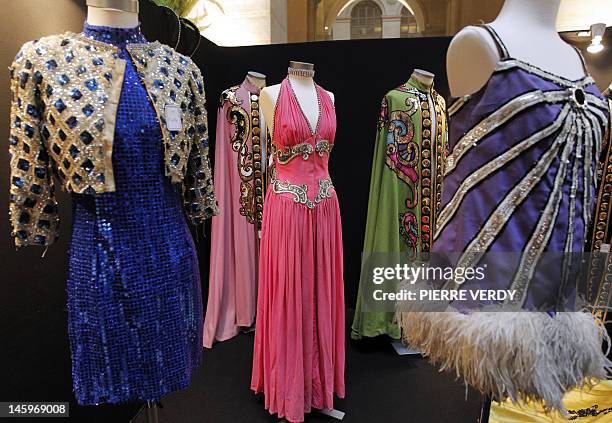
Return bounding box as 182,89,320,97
260,61,334,134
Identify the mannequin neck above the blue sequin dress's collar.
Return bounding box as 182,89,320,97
87,0,139,28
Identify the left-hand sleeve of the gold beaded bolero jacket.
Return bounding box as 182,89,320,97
9,44,59,246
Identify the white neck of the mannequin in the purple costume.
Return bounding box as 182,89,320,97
493,0,561,32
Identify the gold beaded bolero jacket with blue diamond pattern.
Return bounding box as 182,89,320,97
9,33,218,246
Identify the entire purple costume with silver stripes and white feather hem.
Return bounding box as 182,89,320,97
397,26,612,411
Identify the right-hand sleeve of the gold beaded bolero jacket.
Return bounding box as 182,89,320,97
184,64,219,224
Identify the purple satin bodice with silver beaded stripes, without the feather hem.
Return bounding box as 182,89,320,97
433,26,609,311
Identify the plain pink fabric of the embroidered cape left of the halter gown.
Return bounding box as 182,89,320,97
204,81,259,348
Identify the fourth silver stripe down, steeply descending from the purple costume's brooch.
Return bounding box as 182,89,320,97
506,119,577,307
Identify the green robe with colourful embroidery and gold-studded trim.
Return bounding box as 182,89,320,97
351,78,448,339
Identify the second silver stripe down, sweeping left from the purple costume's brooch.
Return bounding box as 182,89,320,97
434,104,571,239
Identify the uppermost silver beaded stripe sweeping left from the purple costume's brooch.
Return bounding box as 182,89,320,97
445,90,570,176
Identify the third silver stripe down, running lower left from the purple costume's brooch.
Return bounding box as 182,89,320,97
445,112,575,289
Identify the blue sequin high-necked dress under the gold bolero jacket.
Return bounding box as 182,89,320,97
67,24,202,405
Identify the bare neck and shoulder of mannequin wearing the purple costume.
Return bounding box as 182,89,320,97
447,0,584,97
